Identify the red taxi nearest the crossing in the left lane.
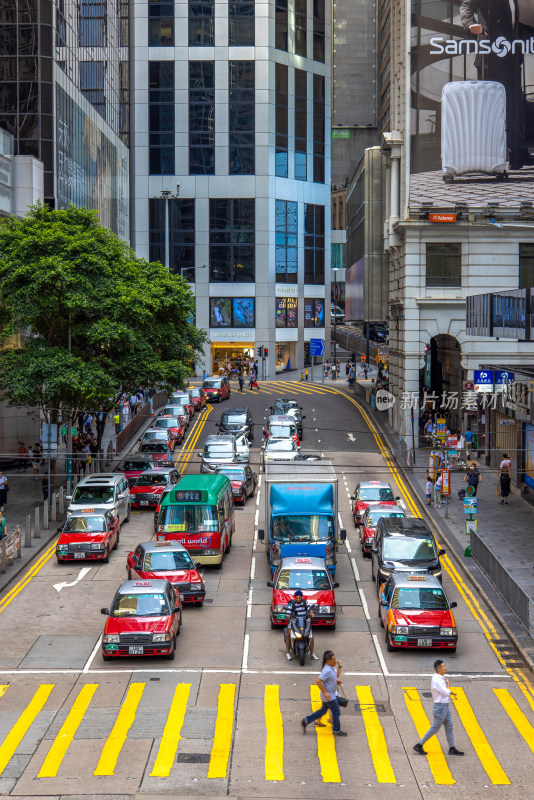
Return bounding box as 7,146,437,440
100,580,182,661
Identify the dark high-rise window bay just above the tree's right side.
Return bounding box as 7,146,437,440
148,198,195,283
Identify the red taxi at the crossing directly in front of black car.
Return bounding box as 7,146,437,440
379,572,458,653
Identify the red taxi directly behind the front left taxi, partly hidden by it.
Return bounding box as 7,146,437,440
126,542,206,606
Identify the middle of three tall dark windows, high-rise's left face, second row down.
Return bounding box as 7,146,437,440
189,61,215,175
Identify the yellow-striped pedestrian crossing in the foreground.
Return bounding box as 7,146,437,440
0,682,534,786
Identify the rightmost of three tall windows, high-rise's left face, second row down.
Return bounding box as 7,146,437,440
228,61,255,175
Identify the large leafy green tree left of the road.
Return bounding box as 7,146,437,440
0,205,205,454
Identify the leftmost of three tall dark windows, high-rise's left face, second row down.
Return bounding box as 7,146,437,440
148,61,174,175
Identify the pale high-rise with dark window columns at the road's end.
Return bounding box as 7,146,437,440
131,0,330,376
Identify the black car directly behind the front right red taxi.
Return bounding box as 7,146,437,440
371,517,445,592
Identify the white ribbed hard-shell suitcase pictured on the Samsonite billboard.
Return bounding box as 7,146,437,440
441,81,508,183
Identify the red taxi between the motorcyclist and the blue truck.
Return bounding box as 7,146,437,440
267,545,339,630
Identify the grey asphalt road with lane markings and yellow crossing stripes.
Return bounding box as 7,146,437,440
0,382,534,800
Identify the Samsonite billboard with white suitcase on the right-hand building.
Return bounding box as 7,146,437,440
410,0,534,206
